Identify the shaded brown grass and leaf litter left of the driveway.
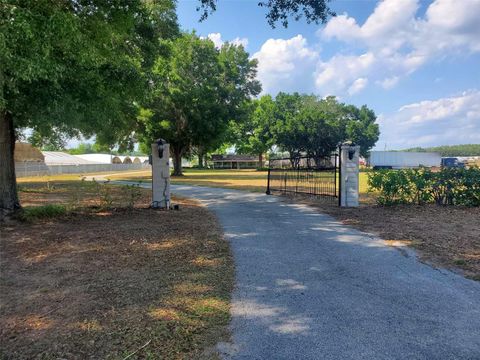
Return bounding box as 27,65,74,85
0,182,233,359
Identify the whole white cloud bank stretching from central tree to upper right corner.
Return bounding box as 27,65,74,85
254,0,480,95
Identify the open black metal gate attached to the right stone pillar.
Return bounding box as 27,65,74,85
266,154,339,201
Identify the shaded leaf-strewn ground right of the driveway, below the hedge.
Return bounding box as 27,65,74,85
284,197,480,281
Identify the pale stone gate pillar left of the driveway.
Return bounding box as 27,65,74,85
152,139,170,209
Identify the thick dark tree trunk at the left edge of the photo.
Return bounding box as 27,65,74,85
0,111,20,220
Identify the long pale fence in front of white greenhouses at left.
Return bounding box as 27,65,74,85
15,162,150,178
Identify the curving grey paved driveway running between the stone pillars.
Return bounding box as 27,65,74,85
172,185,480,359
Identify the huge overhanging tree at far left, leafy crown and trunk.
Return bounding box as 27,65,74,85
0,0,178,214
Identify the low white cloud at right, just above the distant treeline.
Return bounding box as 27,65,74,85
377,89,480,149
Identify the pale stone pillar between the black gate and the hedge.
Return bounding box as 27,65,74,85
340,145,360,207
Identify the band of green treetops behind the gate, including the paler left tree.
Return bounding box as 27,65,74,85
235,93,379,167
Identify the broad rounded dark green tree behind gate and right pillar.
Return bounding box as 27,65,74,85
272,93,379,166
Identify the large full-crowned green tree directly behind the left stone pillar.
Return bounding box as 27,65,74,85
138,33,260,176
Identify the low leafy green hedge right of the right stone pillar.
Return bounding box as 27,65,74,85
368,167,480,206
